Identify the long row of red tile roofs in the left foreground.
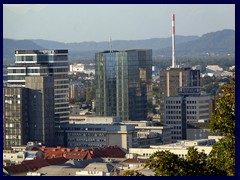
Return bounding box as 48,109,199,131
5,146,125,174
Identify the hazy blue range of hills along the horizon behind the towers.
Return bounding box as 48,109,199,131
3,30,235,63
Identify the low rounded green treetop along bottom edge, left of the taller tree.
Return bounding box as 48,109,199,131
145,147,226,176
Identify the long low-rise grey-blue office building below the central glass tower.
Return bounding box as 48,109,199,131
56,116,171,151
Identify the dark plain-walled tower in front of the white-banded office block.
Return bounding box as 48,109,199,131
25,76,55,146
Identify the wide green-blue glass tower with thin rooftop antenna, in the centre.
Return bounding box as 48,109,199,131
95,50,152,121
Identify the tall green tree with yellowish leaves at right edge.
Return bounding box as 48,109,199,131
209,79,235,176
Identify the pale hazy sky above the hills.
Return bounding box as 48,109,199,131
3,4,235,42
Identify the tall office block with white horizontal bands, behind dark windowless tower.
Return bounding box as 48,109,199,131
7,50,69,127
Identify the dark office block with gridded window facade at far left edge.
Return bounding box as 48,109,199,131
3,87,29,150
